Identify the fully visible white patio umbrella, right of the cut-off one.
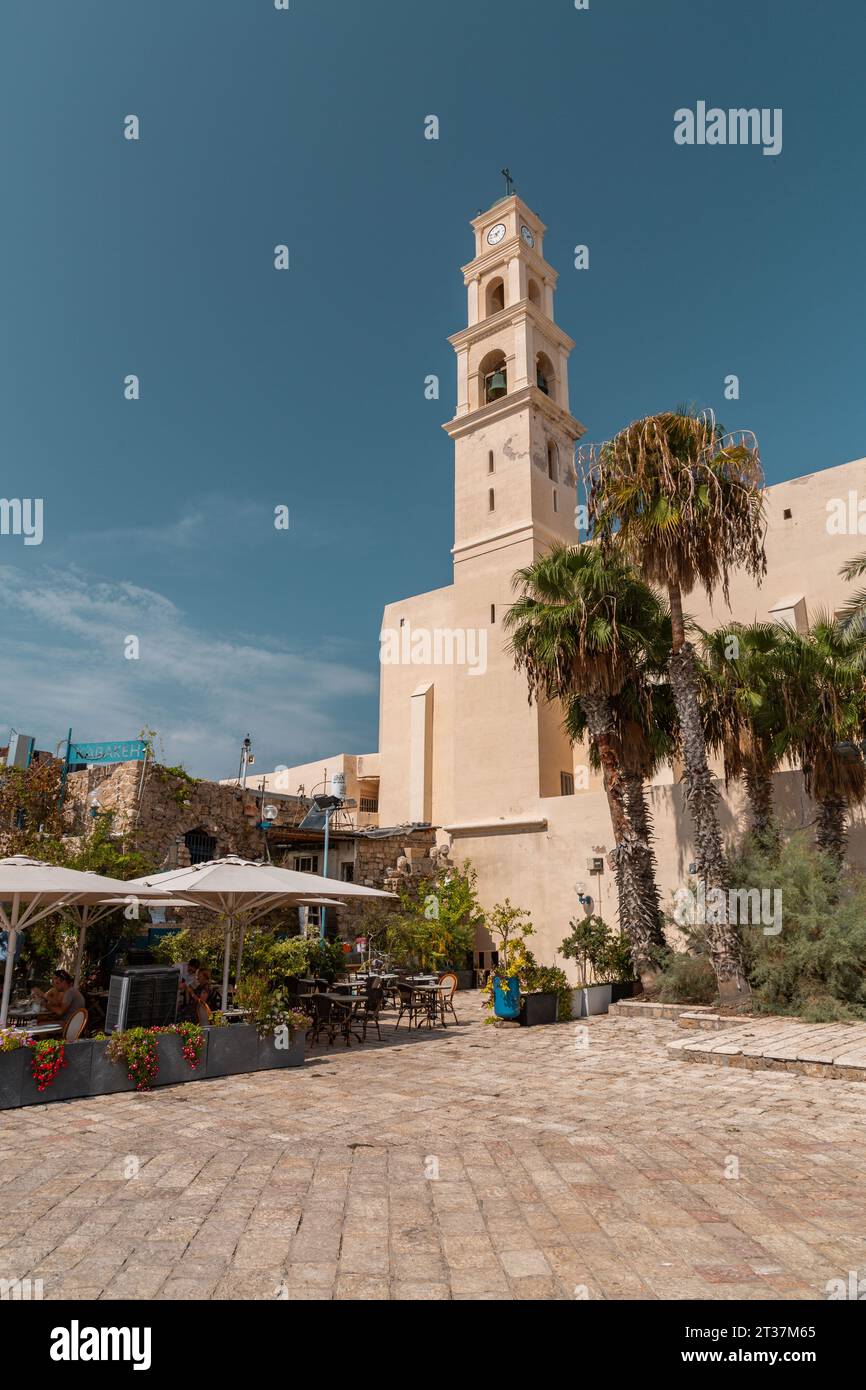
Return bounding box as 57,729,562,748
126,855,396,1008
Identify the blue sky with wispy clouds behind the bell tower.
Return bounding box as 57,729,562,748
0,0,866,776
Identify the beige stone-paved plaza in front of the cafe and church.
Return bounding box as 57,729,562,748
0,994,866,1300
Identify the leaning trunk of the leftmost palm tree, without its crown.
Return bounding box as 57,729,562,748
581,695,659,990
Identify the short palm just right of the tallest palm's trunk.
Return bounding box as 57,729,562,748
702,623,788,853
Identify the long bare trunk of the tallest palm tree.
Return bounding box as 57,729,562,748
669,584,751,1004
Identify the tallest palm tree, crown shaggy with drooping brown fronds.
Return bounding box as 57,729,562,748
584,407,766,1002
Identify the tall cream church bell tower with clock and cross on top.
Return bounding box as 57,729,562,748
443,187,584,820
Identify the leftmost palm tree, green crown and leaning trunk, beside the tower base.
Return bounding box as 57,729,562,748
505,545,664,987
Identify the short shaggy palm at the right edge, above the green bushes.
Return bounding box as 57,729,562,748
777,613,866,865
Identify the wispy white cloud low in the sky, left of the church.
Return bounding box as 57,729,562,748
0,566,377,777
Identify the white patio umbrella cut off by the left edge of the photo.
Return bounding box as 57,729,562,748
0,855,180,1027
